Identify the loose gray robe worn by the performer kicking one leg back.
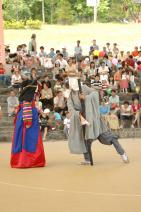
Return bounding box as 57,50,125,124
67,85,107,154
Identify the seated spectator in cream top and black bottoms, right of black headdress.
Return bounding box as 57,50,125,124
41,82,53,109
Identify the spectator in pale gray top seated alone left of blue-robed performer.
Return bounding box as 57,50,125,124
7,91,19,117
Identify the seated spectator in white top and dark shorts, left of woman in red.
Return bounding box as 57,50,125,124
120,101,133,128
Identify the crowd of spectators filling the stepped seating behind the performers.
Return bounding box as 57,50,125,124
0,34,141,140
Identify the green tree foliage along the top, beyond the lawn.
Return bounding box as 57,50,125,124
3,0,141,24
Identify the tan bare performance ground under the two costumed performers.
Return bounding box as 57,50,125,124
0,139,141,212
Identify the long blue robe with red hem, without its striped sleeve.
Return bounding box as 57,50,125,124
10,106,45,168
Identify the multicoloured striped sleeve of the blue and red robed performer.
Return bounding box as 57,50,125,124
23,101,32,126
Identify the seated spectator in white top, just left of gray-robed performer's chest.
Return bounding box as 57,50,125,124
54,91,66,112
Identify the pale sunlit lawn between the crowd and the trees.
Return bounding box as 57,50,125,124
5,24,141,54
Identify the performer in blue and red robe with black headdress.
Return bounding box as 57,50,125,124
10,79,45,168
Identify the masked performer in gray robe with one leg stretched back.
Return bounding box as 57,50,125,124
67,78,129,165
